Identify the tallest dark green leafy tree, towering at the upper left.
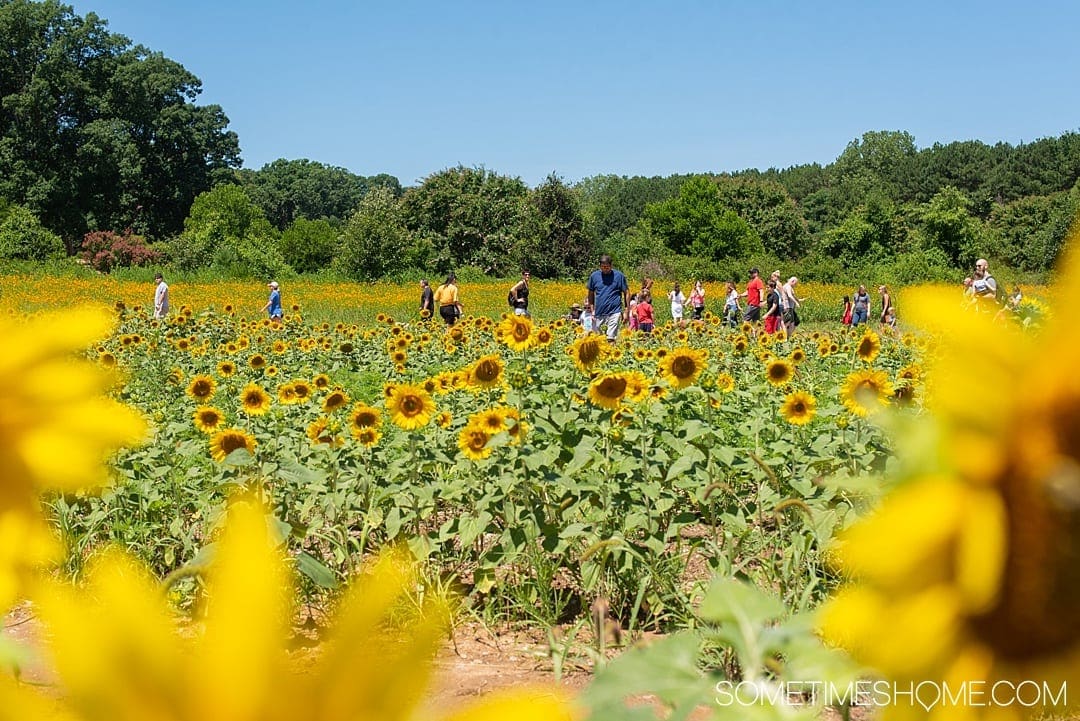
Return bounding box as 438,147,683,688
0,0,240,243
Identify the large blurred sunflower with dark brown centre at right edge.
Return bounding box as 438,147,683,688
821,240,1080,718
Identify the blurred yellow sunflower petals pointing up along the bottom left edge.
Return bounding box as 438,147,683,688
0,502,571,721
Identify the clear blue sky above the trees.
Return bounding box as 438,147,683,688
75,0,1080,186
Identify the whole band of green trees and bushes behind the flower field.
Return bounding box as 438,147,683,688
0,0,1080,283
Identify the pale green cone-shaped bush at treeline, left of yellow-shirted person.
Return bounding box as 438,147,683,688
334,188,427,281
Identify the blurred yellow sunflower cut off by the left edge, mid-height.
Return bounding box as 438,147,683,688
0,309,146,612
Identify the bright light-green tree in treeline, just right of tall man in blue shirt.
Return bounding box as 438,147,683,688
644,176,764,260
